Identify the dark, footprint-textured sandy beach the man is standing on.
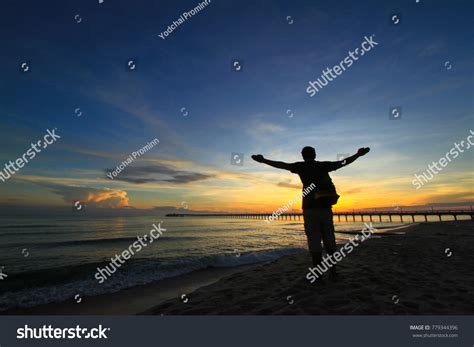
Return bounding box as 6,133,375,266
144,221,474,315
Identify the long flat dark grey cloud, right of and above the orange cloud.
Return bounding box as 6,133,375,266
104,164,214,184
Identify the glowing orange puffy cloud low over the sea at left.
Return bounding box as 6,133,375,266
37,182,128,208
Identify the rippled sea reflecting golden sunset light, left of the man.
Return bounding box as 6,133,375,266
0,215,410,313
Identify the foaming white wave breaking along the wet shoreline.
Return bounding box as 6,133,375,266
0,248,305,311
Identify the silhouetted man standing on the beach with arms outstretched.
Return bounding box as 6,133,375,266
252,147,370,278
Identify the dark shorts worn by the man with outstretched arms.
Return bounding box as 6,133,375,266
303,207,336,254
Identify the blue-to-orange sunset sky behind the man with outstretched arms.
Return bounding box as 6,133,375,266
0,0,474,212
